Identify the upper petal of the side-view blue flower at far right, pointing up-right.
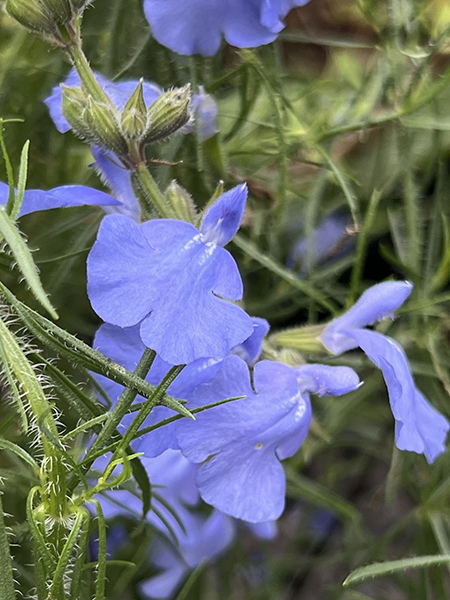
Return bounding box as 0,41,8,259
320,281,413,354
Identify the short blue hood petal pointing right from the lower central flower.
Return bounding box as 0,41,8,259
294,364,361,396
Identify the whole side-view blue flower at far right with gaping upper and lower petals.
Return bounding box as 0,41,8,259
321,281,450,463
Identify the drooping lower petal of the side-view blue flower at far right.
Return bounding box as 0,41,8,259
349,329,450,463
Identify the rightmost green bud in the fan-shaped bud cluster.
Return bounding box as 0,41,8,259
144,84,191,143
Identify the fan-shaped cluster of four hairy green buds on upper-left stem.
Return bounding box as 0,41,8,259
61,80,191,157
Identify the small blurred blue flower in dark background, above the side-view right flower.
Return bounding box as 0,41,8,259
287,211,354,274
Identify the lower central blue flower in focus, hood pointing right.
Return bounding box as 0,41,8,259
176,356,359,523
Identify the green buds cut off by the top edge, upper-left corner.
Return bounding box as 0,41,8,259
6,0,92,34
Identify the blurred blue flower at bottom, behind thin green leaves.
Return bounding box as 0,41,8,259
93,450,235,598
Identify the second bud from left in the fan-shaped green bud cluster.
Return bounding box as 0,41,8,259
84,97,128,156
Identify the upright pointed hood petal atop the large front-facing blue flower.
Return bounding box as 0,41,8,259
200,183,247,246
